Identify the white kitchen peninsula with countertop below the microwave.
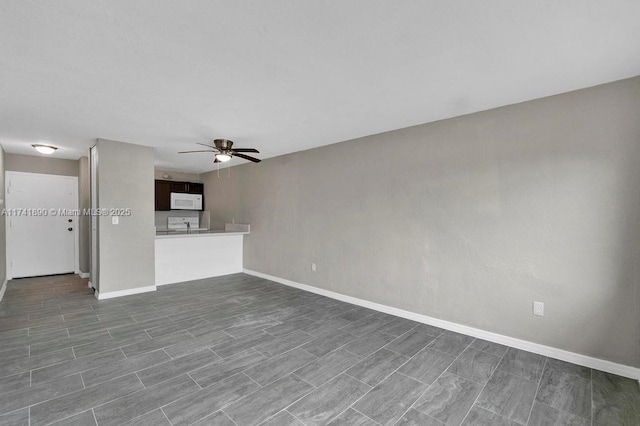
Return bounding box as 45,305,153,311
155,223,250,286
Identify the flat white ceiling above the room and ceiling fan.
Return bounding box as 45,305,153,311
0,0,640,172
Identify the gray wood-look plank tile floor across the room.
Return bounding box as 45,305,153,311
0,274,640,426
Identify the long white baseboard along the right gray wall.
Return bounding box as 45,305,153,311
243,269,640,380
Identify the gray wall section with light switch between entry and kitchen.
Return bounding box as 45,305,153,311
97,139,155,293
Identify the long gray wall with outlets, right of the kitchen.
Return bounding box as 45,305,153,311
203,78,640,367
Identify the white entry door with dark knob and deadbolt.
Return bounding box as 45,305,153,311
5,172,78,278
